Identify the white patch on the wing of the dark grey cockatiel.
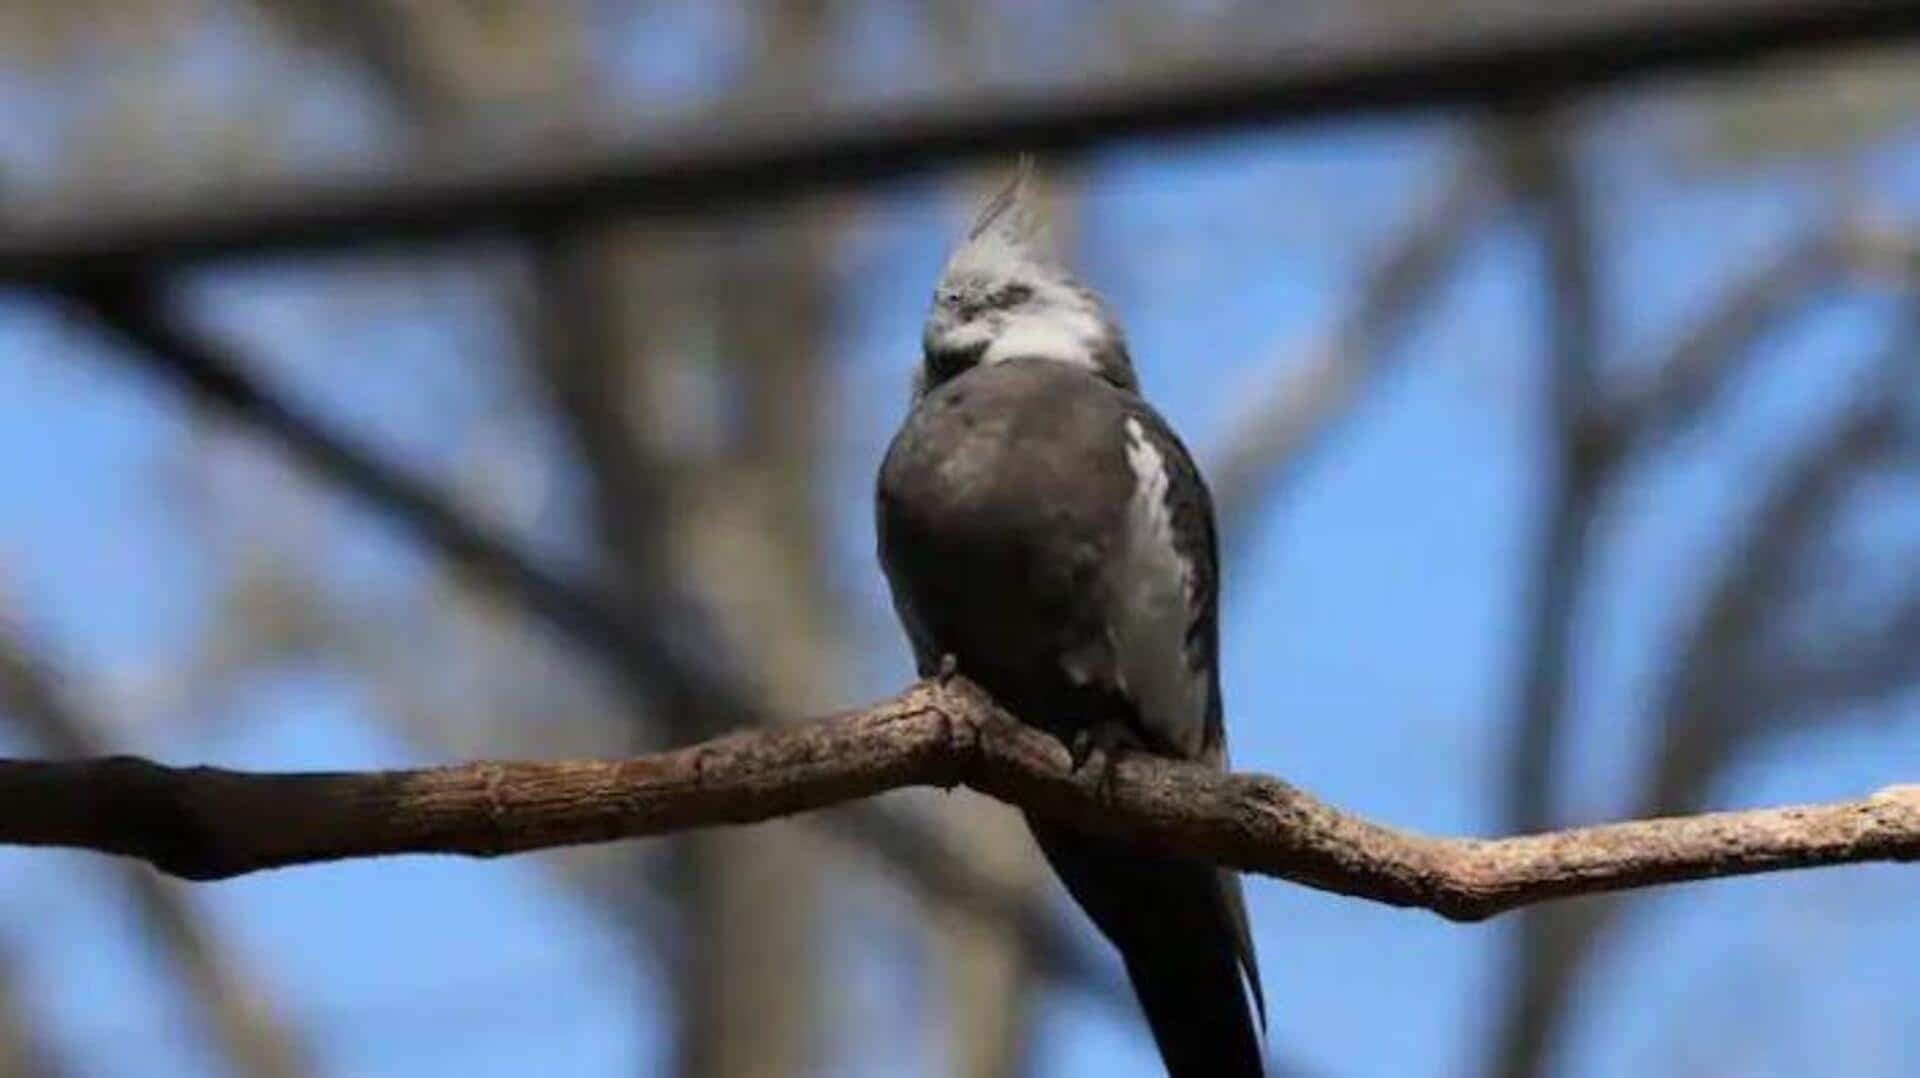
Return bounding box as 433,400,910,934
1112,415,1208,759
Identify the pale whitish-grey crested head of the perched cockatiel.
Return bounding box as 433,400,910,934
914,159,1139,398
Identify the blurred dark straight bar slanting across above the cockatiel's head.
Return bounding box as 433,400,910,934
0,0,1920,276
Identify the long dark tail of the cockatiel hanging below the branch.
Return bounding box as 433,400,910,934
1027,817,1265,1078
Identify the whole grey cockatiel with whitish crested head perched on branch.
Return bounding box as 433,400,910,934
876,165,1265,1078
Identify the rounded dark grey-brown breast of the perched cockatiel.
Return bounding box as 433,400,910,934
877,367,1131,696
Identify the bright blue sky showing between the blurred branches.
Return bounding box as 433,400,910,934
0,13,1920,1076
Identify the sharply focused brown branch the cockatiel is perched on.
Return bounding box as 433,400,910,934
0,678,1920,920
